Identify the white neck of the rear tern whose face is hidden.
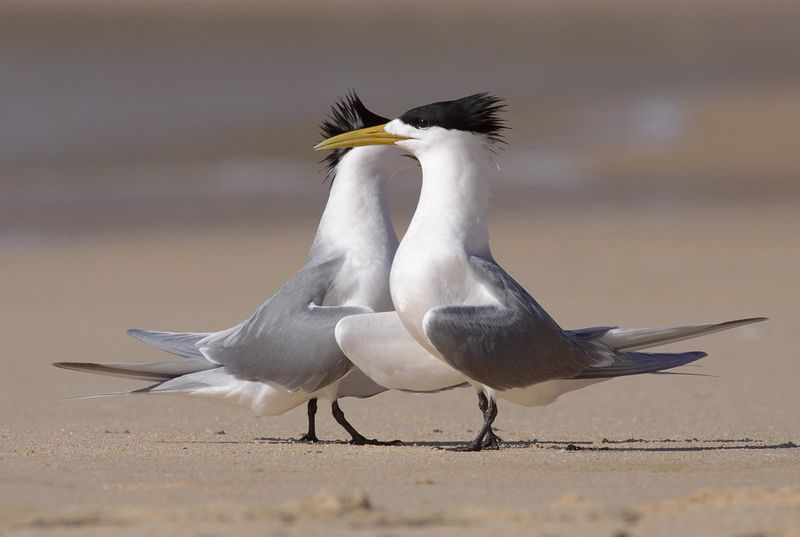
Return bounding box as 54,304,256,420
310,149,398,259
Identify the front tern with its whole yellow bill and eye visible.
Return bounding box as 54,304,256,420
315,93,764,451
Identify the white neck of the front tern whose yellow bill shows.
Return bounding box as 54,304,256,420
408,141,496,255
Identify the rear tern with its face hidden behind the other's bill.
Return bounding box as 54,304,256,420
53,92,411,445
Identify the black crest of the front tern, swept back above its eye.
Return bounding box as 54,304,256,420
400,93,508,142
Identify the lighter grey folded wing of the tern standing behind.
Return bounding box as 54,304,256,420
202,258,372,392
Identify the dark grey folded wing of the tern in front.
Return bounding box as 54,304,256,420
423,256,603,390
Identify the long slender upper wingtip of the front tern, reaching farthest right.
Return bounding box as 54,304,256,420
575,317,767,351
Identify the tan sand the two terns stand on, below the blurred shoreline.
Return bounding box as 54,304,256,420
0,201,800,537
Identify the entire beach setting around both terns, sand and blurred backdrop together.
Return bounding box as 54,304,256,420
0,0,800,537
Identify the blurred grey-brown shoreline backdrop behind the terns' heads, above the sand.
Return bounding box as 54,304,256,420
0,0,800,247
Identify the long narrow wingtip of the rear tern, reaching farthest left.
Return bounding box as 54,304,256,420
53,358,219,382
